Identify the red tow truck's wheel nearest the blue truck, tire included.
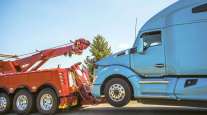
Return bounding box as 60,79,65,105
36,88,59,114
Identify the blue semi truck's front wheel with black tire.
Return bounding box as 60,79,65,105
104,78,132,107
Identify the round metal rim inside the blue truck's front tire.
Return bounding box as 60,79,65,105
109,84,126,102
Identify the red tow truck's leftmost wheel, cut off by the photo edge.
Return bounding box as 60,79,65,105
0,92,11,114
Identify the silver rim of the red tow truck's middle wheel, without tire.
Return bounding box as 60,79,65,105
16,95,28,111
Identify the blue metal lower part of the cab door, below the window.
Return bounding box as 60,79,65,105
131,40,165,77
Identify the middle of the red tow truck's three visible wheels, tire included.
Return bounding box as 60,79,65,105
13,90,34,115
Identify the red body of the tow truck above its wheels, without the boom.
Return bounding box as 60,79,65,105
0,68,77,105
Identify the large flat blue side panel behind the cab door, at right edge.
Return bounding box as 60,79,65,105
164,21,207,75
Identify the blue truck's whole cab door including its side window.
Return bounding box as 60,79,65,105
130,31,165,77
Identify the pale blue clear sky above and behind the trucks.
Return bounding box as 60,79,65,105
0,0,177,68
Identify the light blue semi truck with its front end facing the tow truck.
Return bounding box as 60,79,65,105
93,0,207,107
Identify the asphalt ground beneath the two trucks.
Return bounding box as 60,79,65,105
8,102,207,115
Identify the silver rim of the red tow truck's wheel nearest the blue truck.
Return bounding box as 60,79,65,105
40,94,53,111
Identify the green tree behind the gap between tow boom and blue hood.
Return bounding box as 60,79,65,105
85,34,111,79
